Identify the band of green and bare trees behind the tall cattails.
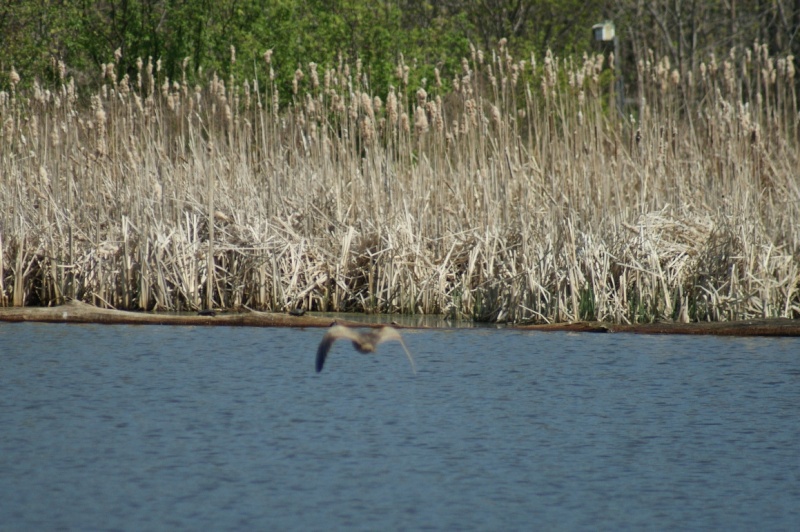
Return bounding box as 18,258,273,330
0,0,800,93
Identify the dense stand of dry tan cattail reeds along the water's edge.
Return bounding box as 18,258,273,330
0,42,800,323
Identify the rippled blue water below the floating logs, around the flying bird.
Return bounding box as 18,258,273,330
0,323,800,530
